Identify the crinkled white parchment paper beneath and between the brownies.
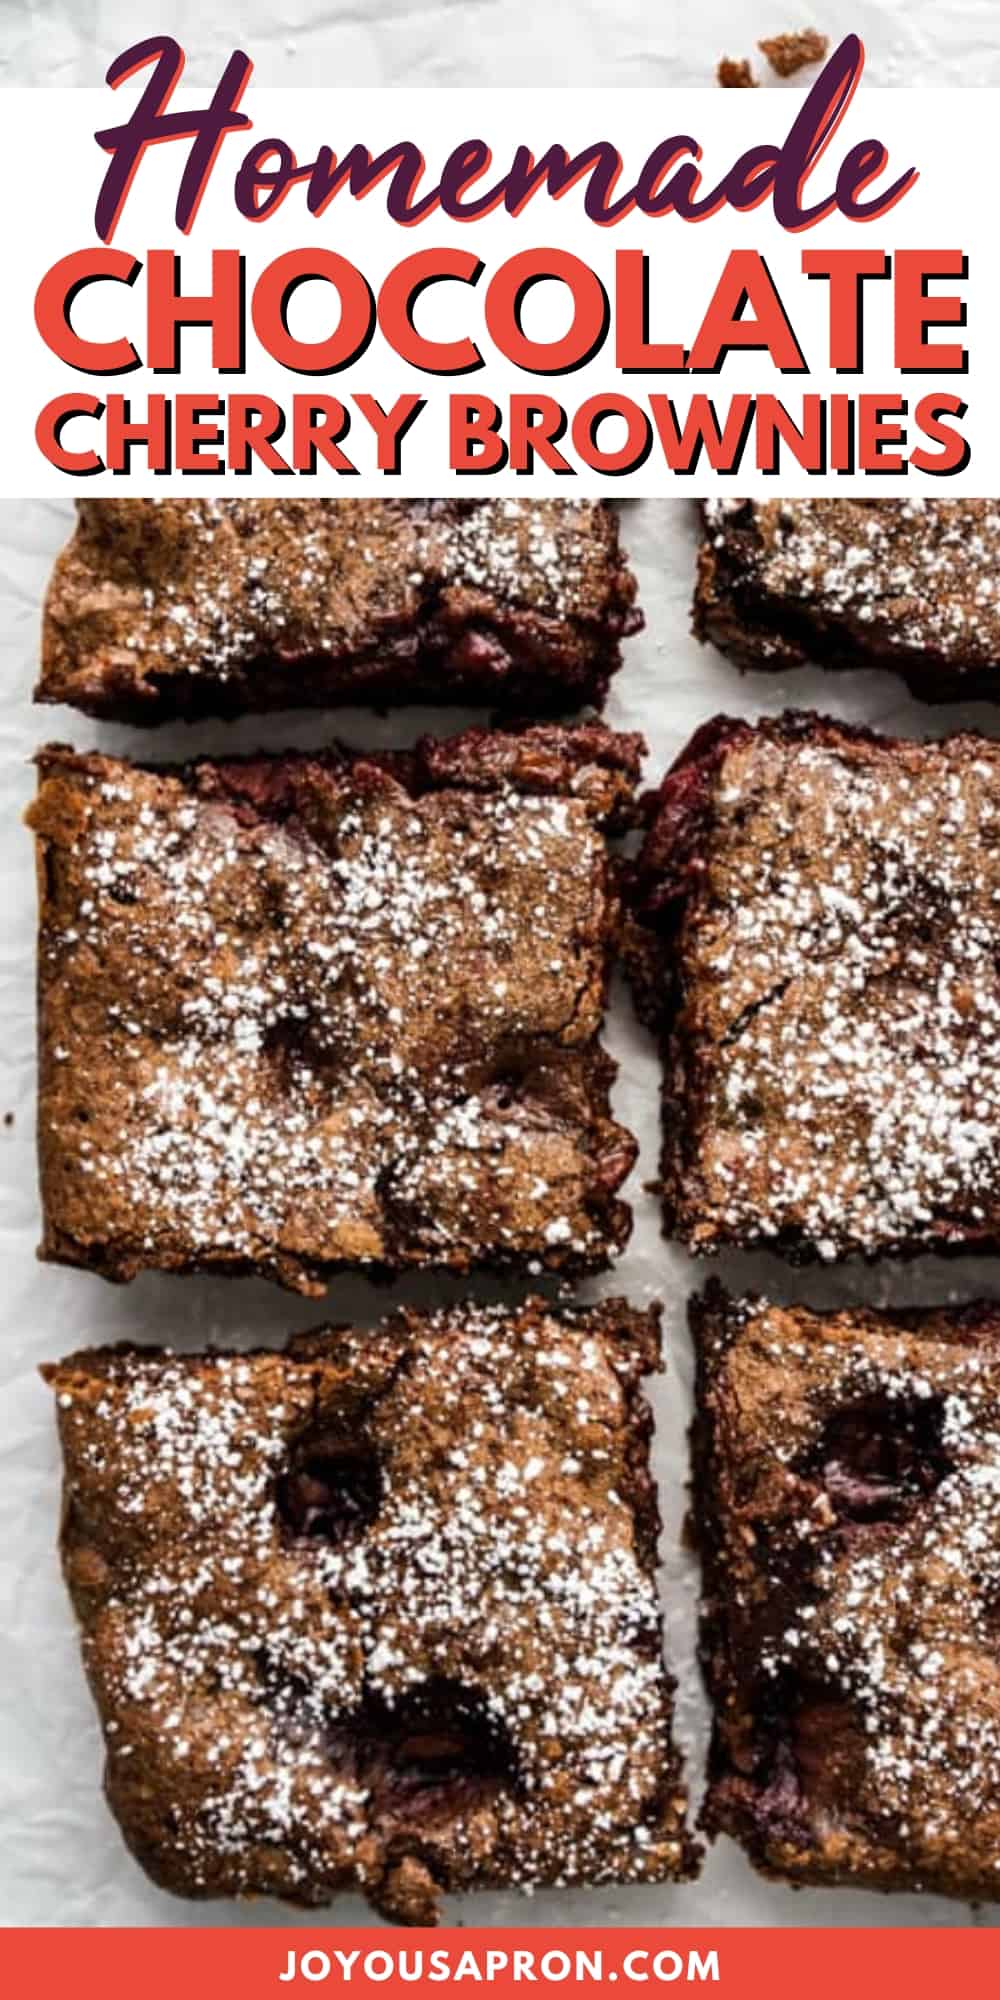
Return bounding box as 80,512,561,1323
0,0,1000,1926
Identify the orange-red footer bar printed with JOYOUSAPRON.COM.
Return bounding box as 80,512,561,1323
0,1928,1000,2000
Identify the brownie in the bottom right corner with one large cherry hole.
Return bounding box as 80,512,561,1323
692,1286,1000,1900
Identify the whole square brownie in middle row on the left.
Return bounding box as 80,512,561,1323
28,724,642,1292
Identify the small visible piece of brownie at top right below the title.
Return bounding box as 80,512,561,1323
694,500,1000,702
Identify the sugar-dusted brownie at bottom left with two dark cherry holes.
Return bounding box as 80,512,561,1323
44,1300,696,1924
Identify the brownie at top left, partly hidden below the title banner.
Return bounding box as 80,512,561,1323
36,500,642,722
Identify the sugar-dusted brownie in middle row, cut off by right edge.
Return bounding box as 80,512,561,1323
630,714,1000,1258
